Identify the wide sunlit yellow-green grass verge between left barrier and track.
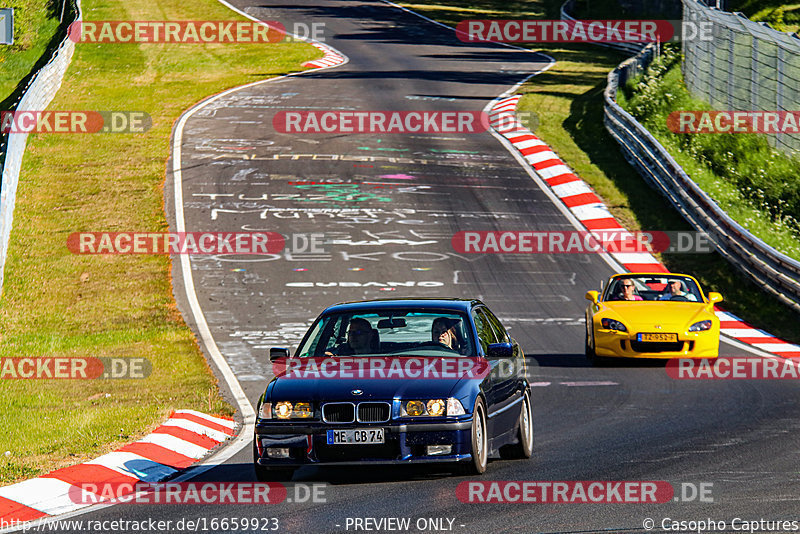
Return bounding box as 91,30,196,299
0,0,321,484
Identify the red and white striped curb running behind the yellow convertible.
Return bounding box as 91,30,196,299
489,95,800,358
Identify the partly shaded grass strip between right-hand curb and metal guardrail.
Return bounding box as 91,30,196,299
403,0,800,343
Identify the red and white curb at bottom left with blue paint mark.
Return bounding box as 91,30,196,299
0,410,236,524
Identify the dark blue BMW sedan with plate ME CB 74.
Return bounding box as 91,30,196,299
253,299,533,481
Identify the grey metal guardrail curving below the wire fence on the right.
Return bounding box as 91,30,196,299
604,44,800,312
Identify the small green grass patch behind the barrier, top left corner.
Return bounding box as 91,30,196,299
0,0,61,105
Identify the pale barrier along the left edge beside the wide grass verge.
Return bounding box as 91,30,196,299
0,0,81,292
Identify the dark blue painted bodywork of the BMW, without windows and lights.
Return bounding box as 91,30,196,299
254,299,529,467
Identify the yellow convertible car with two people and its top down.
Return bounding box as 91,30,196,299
586,273,722,365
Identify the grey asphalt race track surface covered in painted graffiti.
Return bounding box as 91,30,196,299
51,0,800,534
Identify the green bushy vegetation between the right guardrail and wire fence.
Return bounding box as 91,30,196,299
619,45,800,260
